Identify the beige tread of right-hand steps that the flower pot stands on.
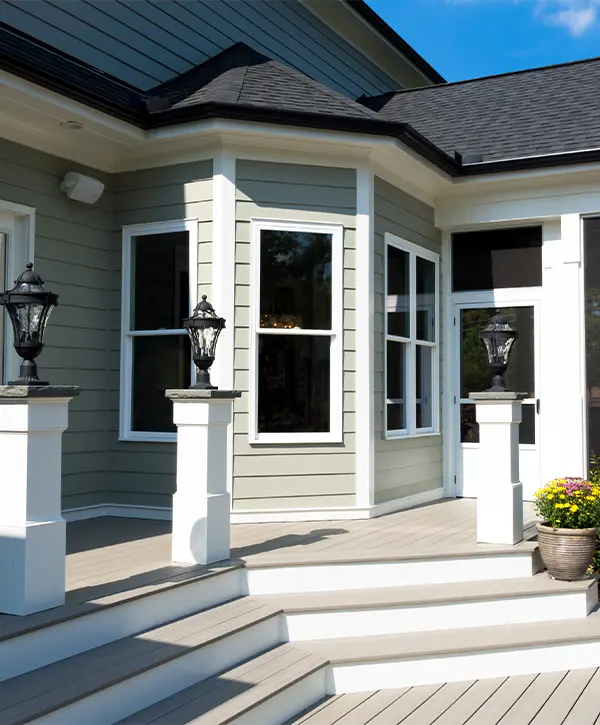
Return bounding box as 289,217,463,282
251,572,597,613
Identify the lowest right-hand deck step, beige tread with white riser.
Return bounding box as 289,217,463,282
301,609,600,694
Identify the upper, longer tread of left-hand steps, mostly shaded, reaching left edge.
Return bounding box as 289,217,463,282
0,597,280,725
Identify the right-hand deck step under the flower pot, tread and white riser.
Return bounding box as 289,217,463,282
256,572,598,642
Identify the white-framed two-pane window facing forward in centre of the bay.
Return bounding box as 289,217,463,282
250,221,343,443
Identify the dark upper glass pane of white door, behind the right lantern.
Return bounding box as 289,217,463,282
460,306,535,398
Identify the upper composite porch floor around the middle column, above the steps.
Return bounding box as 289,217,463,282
0,499,534,639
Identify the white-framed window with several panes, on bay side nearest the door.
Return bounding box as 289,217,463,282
384,234,439,438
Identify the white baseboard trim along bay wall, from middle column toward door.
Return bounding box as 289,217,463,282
231,488,448,524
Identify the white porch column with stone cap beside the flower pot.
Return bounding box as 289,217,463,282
469,392,527,545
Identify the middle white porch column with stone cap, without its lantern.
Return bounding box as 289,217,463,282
166,388,241,564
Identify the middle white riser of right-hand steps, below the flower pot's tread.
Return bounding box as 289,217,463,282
284,591,594,642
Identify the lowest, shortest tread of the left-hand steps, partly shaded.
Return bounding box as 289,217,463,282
117,644,327,725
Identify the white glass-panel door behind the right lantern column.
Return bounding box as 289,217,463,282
455,301,540,500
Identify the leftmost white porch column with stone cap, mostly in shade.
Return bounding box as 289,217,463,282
0,385,78,615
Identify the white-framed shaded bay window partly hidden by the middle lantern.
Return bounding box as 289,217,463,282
119,221,197,441
